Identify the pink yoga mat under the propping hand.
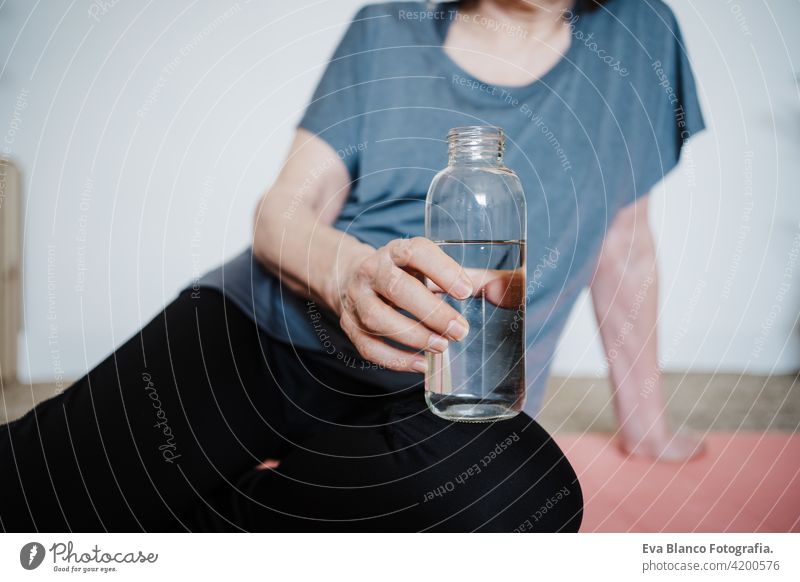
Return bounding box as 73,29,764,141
556,433,800,532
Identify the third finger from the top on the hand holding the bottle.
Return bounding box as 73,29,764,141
353,292,448,353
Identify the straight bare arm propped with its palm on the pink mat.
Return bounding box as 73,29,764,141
591,196,699,459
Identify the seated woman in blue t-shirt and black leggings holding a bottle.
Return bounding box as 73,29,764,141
0,0,702,531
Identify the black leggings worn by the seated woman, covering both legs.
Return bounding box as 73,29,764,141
0,289,583,531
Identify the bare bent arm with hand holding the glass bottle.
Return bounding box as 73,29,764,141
253,129,472,372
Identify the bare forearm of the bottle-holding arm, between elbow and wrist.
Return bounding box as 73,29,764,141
253,193,373,313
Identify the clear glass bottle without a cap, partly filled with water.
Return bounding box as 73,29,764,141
425,126,527,422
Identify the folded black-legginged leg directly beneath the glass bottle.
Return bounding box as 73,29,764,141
193,394,583,532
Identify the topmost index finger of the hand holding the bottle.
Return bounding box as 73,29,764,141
385,237,473,299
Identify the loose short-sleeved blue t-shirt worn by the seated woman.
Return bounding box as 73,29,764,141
202,0,703,413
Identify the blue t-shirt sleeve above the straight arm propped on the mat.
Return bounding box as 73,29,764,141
635,9,705,197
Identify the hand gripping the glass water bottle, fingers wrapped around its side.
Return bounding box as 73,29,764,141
334,237,474,372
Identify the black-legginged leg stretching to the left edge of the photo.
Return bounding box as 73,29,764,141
0,290,294,531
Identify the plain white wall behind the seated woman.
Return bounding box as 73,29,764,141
0,0,800,388
